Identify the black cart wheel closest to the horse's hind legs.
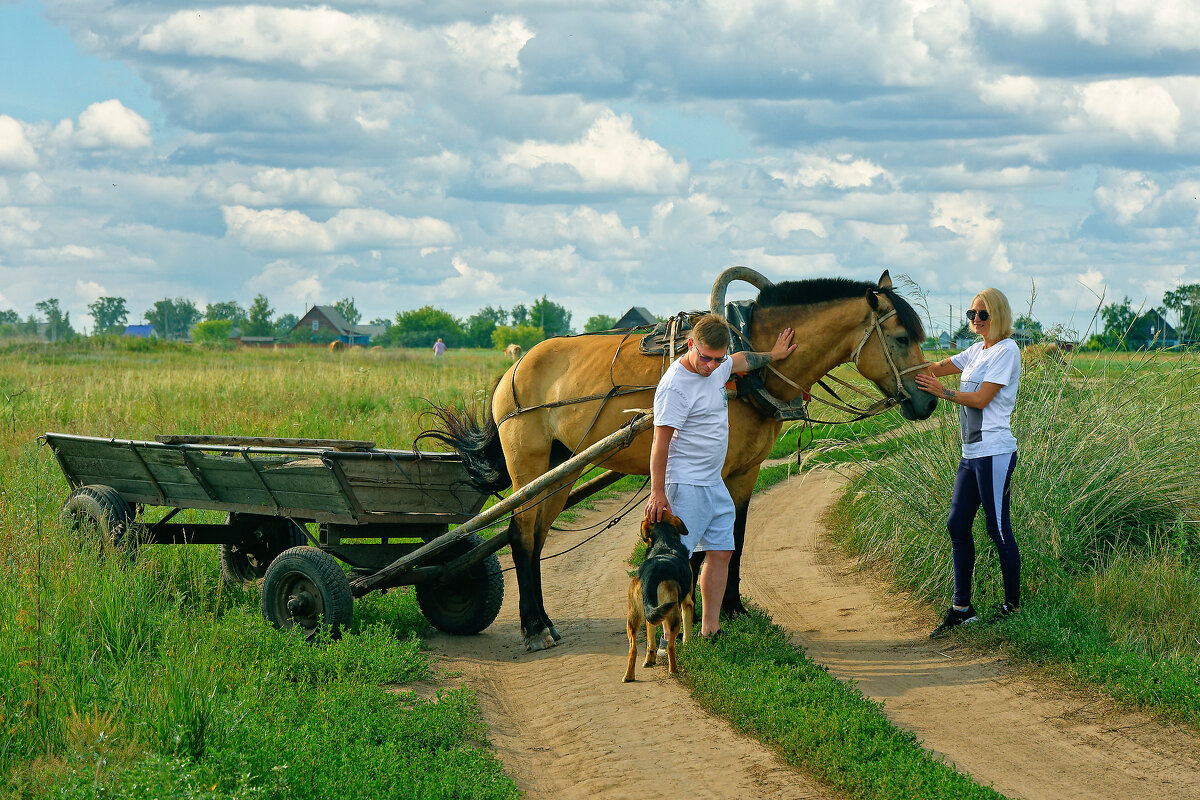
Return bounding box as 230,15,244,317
416,534,504,636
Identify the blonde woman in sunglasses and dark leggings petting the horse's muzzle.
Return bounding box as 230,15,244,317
917,289,1021,638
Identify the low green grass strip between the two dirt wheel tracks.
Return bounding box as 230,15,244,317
679,609,1003,800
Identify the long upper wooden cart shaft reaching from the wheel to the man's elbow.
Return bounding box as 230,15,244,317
350,413,654,597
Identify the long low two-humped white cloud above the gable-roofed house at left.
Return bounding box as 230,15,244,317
222,205,455,253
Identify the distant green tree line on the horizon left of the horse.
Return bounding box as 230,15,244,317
0,294,633,349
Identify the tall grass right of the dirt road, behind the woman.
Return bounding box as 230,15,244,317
832,353,1200,726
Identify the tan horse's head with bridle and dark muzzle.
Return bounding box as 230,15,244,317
851,270,937,420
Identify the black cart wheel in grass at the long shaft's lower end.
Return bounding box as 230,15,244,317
263,547,354,638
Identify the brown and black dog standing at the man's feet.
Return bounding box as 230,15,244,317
624,513,696,682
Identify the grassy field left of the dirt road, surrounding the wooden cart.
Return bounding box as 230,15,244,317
0,345,517,798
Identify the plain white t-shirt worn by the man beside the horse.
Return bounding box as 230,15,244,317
654,357,733,486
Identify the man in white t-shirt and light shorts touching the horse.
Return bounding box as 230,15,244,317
646,314,796,646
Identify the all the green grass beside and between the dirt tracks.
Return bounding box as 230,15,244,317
7,344,1200,798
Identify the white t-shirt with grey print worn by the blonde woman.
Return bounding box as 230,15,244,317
950,338,1021,458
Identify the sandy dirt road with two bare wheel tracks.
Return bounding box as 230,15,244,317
432,471,1200,800
